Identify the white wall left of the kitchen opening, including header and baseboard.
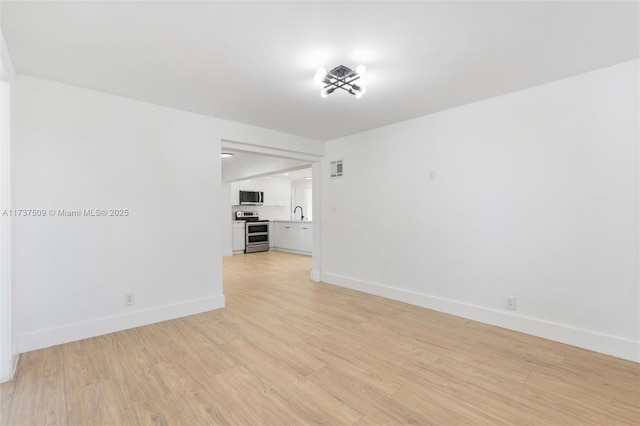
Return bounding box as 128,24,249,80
12,76,322,352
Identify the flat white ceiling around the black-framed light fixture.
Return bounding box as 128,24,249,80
1,1,639,140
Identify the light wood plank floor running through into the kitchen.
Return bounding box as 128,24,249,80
0,251,640,425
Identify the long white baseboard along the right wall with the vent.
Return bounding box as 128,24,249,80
321,272,640,362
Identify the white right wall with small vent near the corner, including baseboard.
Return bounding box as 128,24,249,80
322,61,640,361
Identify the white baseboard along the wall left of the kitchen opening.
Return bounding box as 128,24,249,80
18,295,225,352
